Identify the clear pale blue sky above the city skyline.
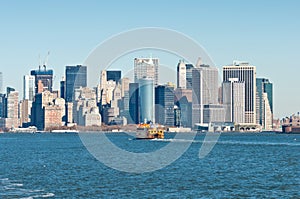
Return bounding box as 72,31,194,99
0,0,300,117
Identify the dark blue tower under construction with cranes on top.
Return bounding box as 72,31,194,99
30,66,53,93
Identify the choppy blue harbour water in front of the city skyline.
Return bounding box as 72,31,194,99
0,133,300,198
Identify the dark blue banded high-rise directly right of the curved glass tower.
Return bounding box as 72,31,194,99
155,85,174,126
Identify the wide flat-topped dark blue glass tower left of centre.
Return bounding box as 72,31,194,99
65,65,87,102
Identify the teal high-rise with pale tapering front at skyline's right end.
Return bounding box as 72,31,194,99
256,78,273,130
